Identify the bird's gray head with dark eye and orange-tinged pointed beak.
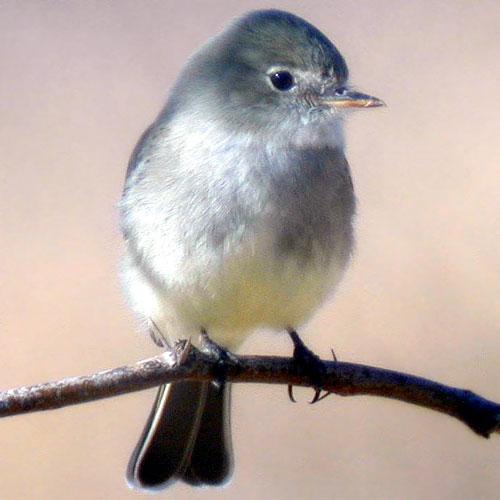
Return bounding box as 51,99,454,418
166,10,383,142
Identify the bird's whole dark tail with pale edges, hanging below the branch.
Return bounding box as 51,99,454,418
127,382,232,490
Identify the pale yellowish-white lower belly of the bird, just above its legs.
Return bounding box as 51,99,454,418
124,230,347,349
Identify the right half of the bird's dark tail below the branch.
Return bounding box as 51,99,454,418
182,384,233,486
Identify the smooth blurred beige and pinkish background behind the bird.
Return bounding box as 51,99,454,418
0,0,500,500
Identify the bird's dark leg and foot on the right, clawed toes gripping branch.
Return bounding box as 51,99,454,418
287,329,330,404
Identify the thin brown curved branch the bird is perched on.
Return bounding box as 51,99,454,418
0,347,500,437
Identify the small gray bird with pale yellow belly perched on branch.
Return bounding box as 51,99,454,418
120,10,383,490
